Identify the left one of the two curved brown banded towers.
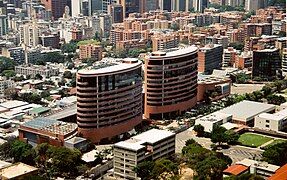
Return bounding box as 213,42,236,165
77,58,142,143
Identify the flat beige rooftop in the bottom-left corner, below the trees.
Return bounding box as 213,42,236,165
0,163,38,179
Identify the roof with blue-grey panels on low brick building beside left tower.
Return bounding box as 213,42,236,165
20,118,78,135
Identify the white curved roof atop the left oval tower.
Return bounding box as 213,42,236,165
78,58,141,75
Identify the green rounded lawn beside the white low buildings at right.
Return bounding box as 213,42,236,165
238,133,272,147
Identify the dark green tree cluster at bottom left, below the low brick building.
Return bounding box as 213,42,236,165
0,139,87,179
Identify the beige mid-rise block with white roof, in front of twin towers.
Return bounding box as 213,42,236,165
114,129,175,179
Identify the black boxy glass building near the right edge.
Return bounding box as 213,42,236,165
252,49,282,80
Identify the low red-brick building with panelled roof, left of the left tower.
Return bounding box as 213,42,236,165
18,118,78,146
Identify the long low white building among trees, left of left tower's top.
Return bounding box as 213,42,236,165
15,64,59,78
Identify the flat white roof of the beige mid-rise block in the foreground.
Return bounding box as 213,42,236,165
115,129,175,151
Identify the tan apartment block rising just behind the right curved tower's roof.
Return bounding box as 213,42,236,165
151,34,179,51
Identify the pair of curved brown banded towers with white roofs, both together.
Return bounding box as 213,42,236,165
77,46,197,143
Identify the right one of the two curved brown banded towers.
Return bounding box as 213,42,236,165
144,46,197,120
